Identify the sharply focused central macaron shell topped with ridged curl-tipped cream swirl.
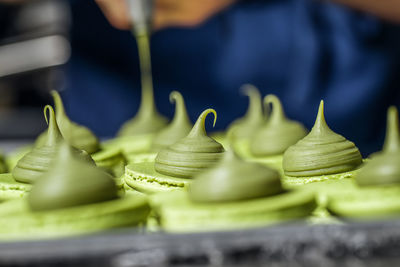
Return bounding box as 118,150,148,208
124,109,224,192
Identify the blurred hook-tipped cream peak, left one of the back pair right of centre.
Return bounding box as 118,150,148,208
228,84,265,138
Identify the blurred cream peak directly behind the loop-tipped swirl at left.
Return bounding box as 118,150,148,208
51,90,100,154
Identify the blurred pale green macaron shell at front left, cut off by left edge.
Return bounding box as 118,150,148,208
0,195,150,240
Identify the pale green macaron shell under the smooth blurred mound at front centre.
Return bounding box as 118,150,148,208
151,190,316,232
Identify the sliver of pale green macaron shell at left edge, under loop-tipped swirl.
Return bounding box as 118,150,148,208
0,173,32,201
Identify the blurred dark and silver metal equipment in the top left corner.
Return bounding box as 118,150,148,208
0,0,70,139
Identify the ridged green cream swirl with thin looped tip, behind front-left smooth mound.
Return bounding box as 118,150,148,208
12,105,94,183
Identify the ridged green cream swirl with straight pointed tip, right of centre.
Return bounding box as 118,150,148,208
283,101,362,177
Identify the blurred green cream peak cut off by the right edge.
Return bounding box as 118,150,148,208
355,106,400,186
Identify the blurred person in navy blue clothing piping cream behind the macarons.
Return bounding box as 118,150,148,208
3,0,400,156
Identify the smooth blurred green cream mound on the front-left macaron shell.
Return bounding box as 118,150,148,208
28,142,117,211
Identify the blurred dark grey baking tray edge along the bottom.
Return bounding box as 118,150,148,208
0,220,400,267
